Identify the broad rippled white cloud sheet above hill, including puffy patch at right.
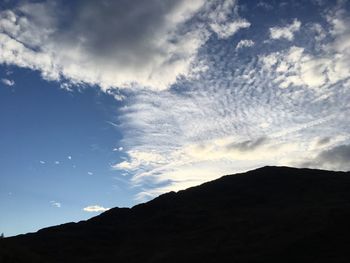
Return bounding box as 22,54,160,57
113,2,350,200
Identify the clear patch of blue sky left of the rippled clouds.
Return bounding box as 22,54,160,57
0,67,136,236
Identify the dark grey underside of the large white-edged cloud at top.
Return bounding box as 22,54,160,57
64,0,190,67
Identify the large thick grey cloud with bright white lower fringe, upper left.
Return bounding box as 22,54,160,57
0,0,250,91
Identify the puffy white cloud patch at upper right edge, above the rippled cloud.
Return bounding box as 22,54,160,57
260,7,350,91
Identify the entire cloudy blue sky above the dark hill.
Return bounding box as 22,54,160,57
0,0,350,236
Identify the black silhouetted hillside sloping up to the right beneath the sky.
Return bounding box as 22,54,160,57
0,167,350,263
